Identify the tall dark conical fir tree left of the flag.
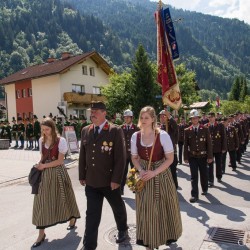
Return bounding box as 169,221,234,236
131,44,157,118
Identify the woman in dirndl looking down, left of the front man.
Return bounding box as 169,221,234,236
32,117,80,247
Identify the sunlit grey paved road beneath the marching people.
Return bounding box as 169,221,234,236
0,147,250,250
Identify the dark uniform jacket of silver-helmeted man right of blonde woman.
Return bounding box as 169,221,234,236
184,125,213,161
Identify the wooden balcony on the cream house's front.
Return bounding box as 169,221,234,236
63,92,106,105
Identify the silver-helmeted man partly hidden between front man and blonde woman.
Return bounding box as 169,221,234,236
121,109,139,195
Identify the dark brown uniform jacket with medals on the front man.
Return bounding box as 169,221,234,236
79,122,126,188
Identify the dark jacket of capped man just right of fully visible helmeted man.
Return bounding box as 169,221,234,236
205,122,227,153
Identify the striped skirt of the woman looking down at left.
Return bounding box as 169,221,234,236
32,165,80,229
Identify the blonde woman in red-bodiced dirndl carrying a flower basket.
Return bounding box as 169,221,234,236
131,106,182,249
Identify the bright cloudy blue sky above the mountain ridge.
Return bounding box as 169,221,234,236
150,0,250,24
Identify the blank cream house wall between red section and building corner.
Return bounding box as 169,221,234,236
32,75,61,120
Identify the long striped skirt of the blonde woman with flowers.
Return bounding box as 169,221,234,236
136,160,182,249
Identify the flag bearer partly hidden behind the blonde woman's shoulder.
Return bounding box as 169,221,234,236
159,108,178,189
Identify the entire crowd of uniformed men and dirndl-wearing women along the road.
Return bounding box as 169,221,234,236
0,102,250,250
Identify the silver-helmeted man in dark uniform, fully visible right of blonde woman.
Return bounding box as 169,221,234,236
184,109,213,203
